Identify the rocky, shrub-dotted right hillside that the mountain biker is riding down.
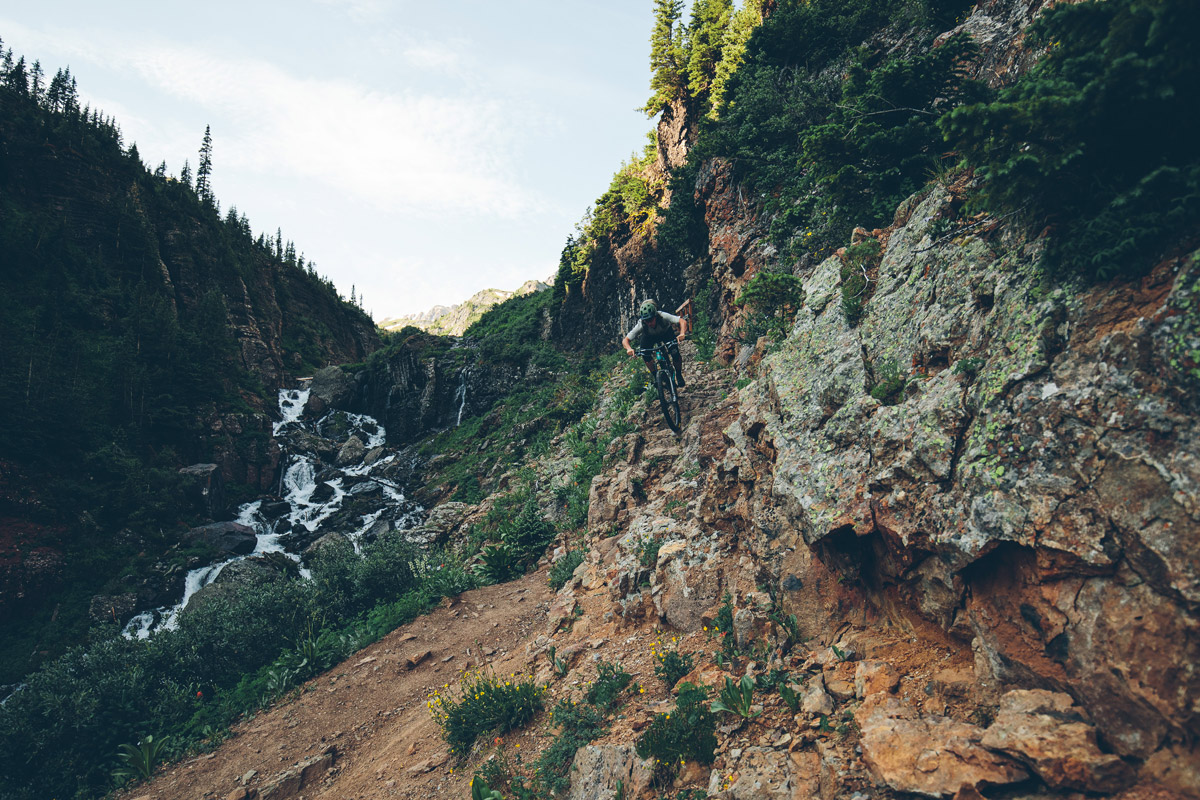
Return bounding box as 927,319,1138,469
0,0,1200,800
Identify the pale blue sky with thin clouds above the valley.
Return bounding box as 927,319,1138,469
0,0,654,321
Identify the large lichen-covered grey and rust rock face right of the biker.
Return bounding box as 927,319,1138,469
740,188,1200,757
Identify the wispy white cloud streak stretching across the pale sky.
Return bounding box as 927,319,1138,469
3,22,546,219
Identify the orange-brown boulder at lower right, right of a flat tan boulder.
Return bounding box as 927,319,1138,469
980,690,1134,793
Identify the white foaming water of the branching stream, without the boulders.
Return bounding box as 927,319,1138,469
121,389,420,639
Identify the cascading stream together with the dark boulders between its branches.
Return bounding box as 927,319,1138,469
122,389,422,639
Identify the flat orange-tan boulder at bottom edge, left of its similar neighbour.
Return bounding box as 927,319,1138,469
856,698,1028,798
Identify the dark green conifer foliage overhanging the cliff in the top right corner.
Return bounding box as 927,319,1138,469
940,0,1200,278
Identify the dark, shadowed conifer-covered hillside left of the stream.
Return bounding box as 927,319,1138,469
0,50,379,684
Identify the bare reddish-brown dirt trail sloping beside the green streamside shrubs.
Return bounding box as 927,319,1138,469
122,570,552,800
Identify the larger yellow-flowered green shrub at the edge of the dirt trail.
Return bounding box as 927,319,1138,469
426,670,546,757
